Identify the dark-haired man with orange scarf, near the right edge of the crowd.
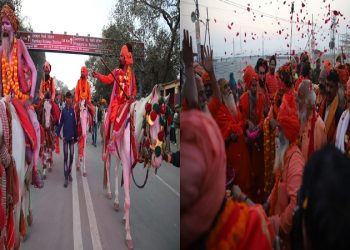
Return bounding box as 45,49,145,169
319,69,343,144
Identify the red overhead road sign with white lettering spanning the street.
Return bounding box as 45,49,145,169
19,32,116,56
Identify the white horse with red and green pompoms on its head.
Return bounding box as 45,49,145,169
103,85,171,249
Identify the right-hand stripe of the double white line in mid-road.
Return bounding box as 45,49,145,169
82,170,102,250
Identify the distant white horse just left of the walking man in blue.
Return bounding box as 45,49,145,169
40,100,55,179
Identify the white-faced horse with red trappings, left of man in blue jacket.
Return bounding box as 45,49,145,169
38,99,58,179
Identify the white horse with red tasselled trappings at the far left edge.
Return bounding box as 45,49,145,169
0,100,33,249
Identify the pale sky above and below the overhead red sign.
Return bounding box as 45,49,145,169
21,0,116,89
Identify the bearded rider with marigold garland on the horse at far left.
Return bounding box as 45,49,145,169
0,3,43,188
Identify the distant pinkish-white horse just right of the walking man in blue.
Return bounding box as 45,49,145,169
76,100,89,177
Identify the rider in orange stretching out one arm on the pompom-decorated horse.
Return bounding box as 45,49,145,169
92,43,137,157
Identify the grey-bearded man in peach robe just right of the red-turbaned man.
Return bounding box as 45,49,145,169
296,80,327,161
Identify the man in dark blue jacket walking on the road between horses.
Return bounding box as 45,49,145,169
56,91,78,188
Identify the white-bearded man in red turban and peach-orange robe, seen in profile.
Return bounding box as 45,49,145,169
264,93,305,249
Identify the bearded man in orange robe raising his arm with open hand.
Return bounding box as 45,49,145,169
202,45,251,195
